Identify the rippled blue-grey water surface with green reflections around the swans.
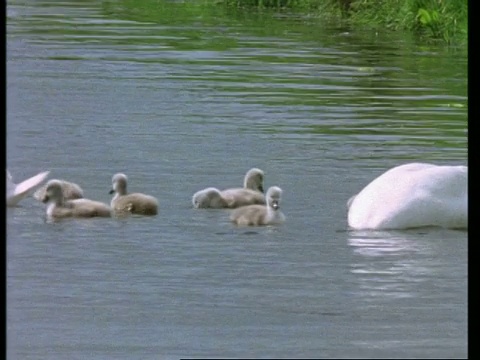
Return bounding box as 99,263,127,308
7,0,468,359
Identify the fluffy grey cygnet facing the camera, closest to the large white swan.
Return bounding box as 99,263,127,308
230,186,285,226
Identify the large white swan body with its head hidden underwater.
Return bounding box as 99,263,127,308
347,163,468,230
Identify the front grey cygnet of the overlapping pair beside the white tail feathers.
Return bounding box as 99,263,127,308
42,179,111,219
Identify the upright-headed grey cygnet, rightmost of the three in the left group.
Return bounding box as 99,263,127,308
110,173,158,215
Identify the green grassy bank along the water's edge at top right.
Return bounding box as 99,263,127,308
219,0,468,43
